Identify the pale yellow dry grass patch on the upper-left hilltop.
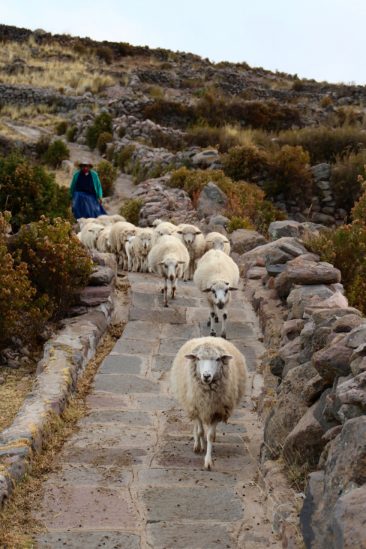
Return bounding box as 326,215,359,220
0,39,115,94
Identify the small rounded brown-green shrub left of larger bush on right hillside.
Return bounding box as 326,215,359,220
221,145,269,181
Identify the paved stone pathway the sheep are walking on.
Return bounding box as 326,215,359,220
35,273,280,549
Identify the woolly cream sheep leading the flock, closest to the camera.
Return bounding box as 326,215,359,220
170,337,248,470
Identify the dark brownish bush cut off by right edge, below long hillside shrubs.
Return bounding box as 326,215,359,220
331,151,366,212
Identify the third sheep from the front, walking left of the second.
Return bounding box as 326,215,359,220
147,235,189,307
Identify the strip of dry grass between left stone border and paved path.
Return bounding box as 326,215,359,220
0,318,127,549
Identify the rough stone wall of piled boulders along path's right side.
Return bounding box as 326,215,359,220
238,218,366,549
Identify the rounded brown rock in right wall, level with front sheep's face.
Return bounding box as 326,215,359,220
312,343,352,383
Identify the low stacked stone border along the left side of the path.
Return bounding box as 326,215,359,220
0,254,117,508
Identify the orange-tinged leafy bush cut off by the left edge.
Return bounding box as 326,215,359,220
0,214,47,348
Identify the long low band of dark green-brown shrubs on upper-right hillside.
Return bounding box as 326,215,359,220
278,126,366,164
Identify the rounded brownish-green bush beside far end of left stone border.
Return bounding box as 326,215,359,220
16,217,92,318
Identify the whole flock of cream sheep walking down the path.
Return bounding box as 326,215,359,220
77,215,247,469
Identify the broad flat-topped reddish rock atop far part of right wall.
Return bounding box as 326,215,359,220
275,261,341,298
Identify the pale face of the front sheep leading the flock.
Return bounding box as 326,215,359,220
186,347,233,385
